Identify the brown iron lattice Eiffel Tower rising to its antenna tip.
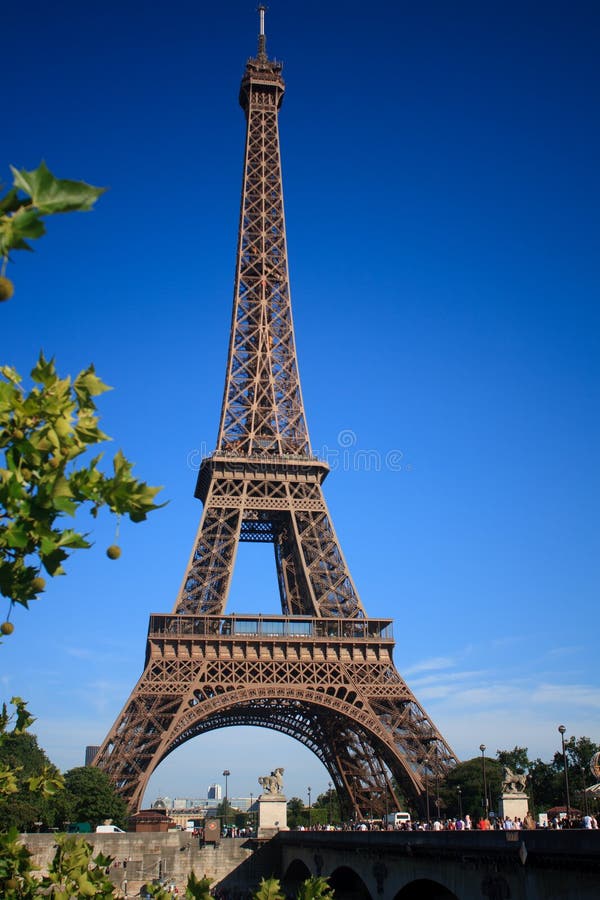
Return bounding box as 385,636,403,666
95,7,456,818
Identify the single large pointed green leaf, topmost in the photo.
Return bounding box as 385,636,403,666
11,162,106,215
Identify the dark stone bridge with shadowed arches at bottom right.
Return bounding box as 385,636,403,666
275,830,600,900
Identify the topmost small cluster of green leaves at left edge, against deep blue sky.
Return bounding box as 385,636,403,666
0,162,105,264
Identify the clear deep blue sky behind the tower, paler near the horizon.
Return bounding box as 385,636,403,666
0,0,600,801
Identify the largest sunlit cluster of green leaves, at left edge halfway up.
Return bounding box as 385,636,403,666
0,354,160,606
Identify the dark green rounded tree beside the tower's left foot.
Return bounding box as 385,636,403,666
65,766,128,828
